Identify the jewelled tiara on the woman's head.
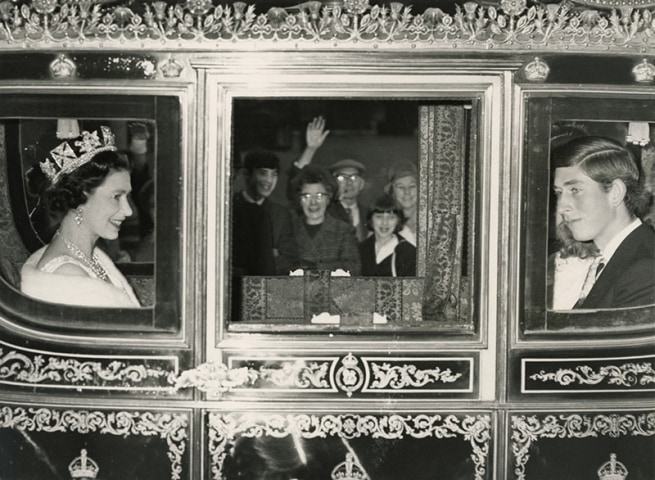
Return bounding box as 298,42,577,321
39,126,117,185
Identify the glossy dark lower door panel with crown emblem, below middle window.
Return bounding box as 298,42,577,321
222,431,477,480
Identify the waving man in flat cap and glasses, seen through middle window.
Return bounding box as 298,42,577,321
288,117,369,242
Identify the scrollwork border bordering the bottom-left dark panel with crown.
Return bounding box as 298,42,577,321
0,406,189,480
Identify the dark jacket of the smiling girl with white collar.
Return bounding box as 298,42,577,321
359,236,416,277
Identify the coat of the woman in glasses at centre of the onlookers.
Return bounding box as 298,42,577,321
293,215,361,275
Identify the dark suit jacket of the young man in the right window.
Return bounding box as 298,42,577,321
576,224,655,308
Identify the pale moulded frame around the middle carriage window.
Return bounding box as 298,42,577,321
206,68,502,344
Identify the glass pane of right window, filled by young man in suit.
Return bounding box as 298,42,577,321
549,122,655,310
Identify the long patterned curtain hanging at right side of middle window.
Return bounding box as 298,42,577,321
418,105,471,326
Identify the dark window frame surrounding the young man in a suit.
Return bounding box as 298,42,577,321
519,90,655,340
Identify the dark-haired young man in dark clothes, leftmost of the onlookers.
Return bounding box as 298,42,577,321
232,150,298,276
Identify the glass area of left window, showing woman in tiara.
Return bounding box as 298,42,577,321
5,118,155,308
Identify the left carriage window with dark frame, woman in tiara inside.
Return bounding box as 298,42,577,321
0,95,181,332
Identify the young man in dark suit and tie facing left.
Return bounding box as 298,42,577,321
553,137,655,308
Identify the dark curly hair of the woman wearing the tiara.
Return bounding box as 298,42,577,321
27,151,131,221
